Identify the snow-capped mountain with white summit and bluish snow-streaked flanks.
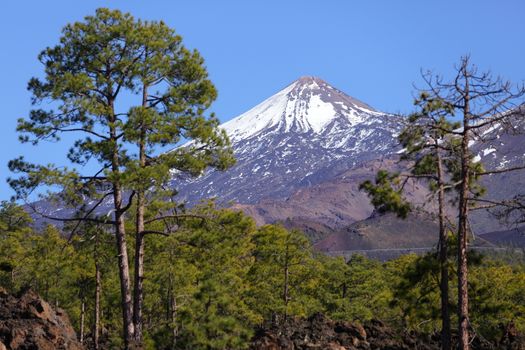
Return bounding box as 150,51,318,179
174,77,401,203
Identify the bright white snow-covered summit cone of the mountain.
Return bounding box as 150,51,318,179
222,76,382,143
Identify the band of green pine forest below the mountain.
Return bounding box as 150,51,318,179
0,202,525,349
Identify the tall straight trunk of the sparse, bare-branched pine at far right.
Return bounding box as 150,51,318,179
458,74,470,350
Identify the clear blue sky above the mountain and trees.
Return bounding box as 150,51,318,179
0,0,525,199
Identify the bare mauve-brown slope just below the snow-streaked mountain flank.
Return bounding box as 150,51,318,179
233,155,432,242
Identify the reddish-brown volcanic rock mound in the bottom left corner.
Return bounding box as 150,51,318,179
0,288,83,350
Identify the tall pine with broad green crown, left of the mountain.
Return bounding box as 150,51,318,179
10,9,232,347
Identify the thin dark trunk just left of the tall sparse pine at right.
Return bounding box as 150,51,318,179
436,148,451,350
